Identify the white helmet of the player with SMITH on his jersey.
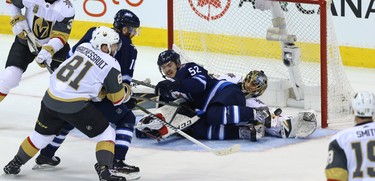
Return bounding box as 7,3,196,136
351,91,375,117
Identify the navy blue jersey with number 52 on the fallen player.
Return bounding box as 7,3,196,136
174,62,233,115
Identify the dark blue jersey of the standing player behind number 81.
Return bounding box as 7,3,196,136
69,27,138,84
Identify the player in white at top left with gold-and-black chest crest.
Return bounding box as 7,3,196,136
0,0,74,101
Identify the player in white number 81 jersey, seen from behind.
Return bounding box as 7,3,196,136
4,27,131,180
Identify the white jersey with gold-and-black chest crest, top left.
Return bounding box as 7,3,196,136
6,0,75,46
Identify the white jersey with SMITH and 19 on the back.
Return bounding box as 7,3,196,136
326,122,375,181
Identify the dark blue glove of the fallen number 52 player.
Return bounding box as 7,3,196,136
155,80,178,101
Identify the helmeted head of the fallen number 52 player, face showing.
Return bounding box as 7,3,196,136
157,50,181,78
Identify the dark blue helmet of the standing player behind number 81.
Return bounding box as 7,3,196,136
113,9,140,30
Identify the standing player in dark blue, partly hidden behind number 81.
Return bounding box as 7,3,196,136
35,9,140,179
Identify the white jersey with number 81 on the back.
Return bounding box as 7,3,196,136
43,43,125,112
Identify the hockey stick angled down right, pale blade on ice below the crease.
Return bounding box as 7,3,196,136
136,105,241,156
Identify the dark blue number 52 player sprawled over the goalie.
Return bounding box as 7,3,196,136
140,50,270,141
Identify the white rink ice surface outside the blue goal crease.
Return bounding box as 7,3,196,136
0,35,375,181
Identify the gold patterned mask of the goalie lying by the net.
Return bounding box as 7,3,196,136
242,70,268,97
